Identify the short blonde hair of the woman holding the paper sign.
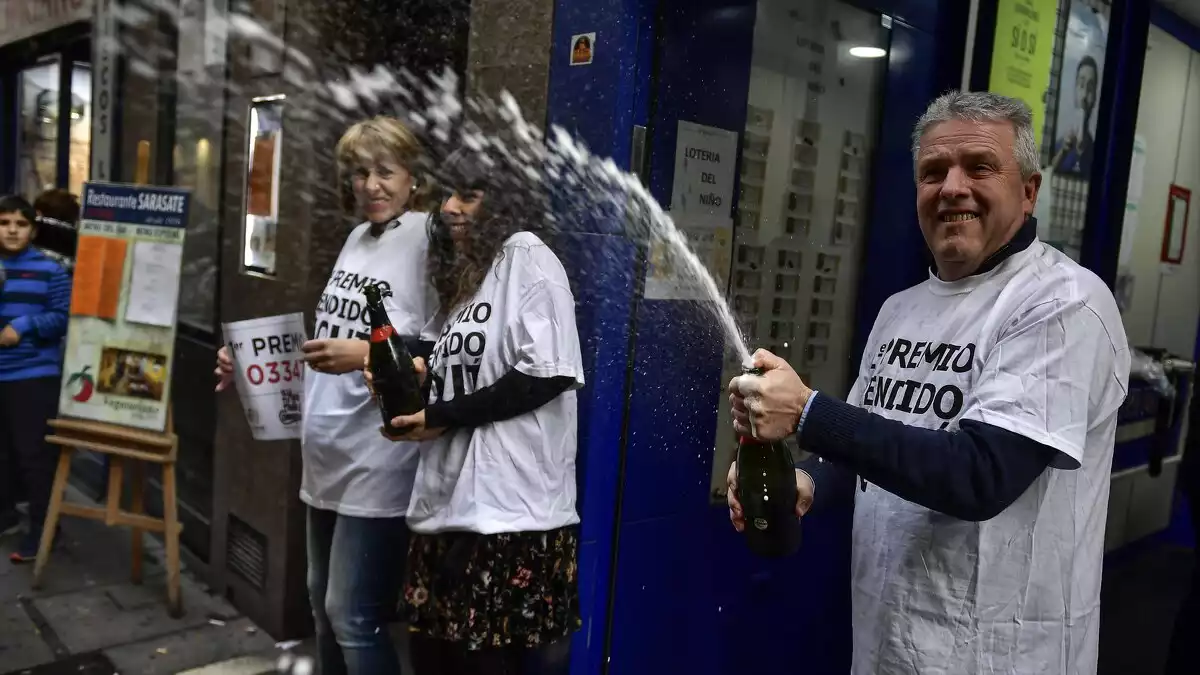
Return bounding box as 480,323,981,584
334,115,437,213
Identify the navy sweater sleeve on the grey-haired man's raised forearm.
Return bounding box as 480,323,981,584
798,394,1057,521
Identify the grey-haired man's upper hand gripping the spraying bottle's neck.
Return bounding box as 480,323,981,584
730,350,812,442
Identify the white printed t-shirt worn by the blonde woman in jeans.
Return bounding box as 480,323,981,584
300,213,437,518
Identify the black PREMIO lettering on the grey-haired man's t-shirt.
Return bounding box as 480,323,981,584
862,338,976,429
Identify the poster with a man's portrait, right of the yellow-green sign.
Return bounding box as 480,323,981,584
1051,0,1109,178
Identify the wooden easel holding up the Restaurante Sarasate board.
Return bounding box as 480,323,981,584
34,406,184,619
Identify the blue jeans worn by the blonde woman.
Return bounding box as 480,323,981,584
308,507,408,675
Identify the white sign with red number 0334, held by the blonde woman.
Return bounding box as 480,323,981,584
223,312,307,441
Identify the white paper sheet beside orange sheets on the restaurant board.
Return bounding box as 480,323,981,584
125,241,184,328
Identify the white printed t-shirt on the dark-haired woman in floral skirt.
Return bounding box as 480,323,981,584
408,232,583,534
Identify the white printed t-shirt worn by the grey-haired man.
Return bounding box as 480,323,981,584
850,241,1129,675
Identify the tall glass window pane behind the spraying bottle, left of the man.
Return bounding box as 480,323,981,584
713,0,888,500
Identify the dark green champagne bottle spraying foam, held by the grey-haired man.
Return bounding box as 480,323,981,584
737,369,800,557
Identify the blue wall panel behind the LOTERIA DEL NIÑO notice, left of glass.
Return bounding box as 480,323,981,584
608,0,755,675
